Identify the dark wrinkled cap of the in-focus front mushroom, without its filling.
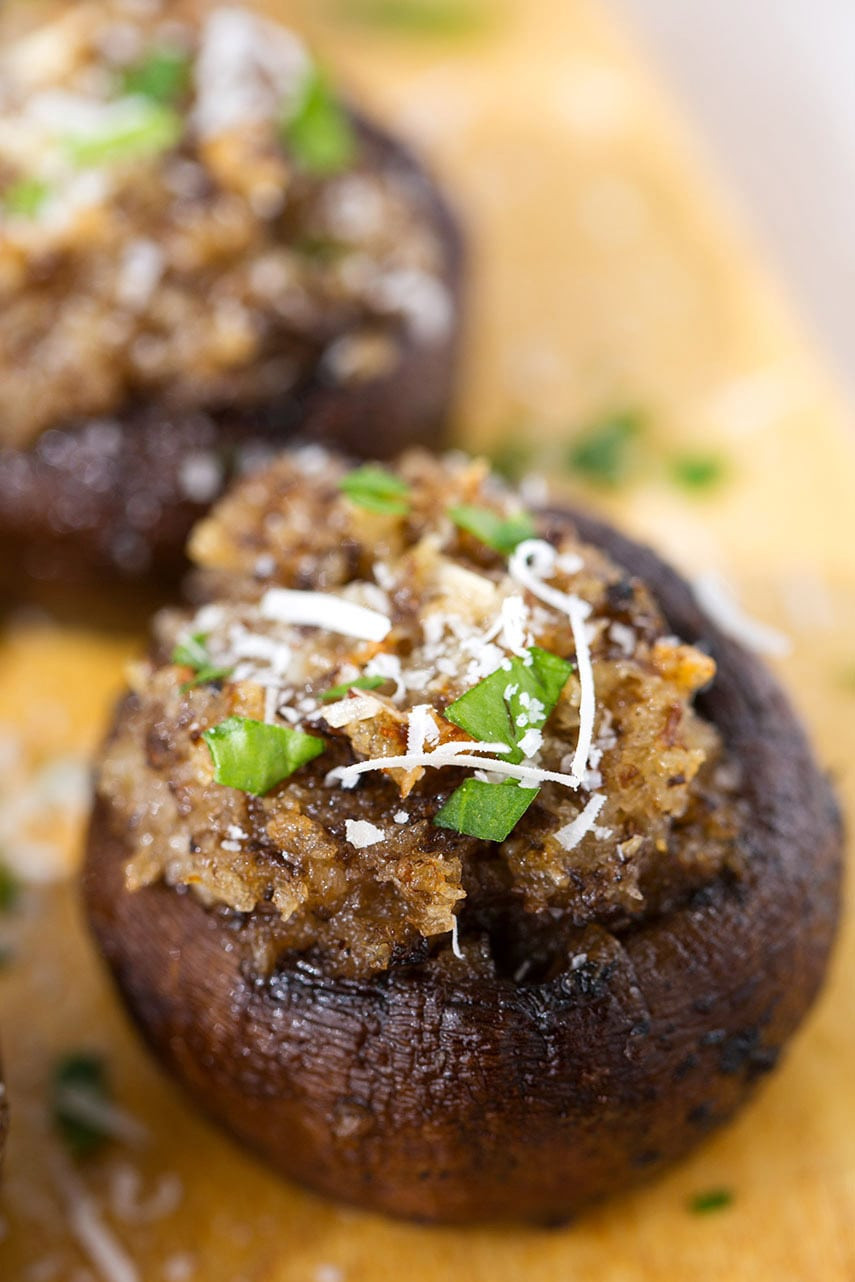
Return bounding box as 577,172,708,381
85,512,842,1223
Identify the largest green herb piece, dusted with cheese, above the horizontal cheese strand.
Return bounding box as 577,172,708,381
445,646,573,764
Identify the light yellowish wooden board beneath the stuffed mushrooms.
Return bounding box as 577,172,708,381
0,0,855,1282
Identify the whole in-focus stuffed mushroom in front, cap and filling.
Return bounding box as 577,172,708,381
85,447,841,1222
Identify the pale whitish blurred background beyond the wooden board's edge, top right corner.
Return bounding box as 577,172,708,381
606,0,855,391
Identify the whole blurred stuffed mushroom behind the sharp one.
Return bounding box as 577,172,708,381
0,0,461,579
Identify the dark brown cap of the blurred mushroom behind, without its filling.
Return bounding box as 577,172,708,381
0,112,464,591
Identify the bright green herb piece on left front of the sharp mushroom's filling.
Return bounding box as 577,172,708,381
204,717,327,797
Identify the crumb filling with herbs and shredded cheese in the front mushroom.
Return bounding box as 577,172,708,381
99,449,740,974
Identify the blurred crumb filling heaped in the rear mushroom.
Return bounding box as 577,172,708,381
0,0,452,451
